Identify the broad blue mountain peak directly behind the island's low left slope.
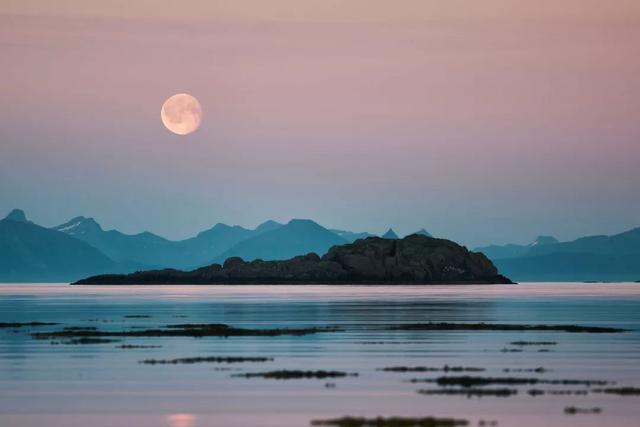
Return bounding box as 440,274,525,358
212,219,347,263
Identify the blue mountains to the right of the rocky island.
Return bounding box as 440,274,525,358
476,228,640,281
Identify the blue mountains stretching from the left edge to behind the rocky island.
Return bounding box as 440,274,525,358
0,209,432,282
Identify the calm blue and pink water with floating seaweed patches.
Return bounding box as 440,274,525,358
0,284,640,427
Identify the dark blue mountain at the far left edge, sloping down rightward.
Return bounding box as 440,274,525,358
0,210,122,282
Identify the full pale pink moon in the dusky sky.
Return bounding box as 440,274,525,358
160,93,202,135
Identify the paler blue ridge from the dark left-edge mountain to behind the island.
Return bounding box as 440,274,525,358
50,213,420,269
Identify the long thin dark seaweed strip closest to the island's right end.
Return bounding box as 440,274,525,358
387,322,629,333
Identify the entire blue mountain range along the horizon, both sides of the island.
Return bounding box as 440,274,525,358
0,209,640,282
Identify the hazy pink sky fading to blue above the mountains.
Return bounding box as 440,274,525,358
0,0,640,247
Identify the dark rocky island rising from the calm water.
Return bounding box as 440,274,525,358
74,234,512,285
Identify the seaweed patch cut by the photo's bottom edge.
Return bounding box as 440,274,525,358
311,417,469,427
